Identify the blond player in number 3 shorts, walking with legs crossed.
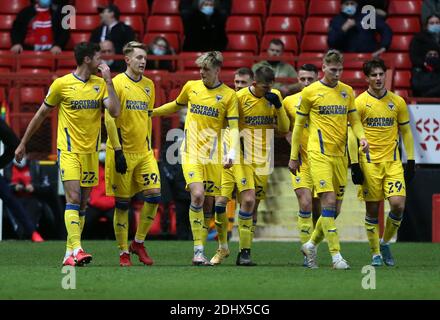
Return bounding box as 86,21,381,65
289,50,368,269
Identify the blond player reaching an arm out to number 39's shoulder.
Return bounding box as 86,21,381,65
153,51,238,265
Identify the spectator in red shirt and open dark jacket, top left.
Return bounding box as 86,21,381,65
11,0,69,54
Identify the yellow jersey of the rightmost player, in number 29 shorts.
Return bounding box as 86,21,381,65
355,91,409,162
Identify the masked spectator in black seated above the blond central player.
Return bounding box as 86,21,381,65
182,0,228,51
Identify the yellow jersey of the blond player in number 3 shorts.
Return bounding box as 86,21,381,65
297,81,356,156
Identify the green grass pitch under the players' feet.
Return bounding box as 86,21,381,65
0,241,440,300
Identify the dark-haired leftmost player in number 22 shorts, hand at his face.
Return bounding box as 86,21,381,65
15,42,120,266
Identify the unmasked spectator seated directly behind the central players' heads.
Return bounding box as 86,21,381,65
252,39,299,96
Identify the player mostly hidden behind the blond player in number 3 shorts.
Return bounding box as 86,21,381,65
283,64,320,266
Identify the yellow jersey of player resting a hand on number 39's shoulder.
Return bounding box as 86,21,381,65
176,80,238,161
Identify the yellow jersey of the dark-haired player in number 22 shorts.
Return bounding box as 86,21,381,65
44,73,107,153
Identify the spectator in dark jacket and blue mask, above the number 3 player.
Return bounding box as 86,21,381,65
328,0,393,56
